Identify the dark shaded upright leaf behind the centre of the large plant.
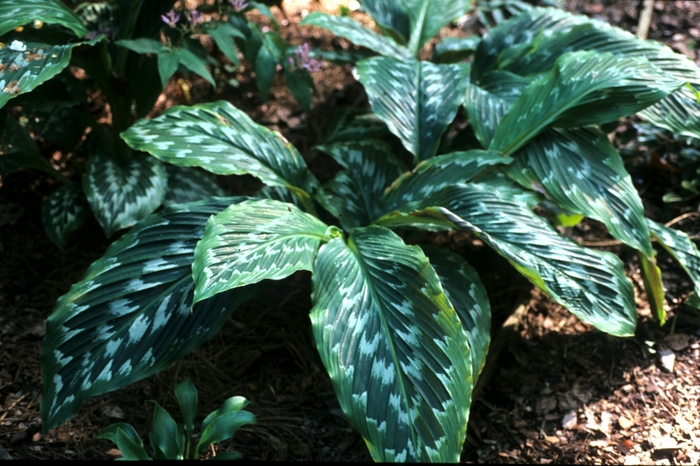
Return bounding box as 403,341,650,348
317,141,406,230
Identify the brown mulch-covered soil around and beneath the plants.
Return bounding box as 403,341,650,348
0,0,700,464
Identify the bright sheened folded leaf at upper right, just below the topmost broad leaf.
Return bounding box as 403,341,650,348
489,52,684,155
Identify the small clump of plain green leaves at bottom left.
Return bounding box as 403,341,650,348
97,379,255,460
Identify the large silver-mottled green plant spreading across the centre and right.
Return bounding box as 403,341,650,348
34,0,698,461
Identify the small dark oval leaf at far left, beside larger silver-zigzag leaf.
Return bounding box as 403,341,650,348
41,183,90,250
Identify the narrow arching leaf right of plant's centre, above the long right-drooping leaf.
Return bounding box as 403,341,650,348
380,150,512,214
